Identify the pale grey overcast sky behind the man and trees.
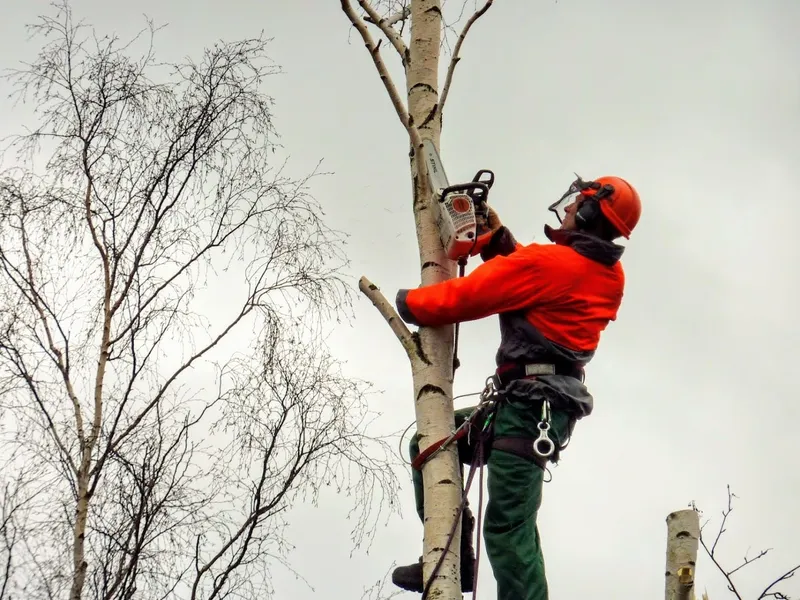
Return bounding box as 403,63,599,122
0,0,800,600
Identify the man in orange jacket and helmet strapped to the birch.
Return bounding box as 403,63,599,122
392,177,641,600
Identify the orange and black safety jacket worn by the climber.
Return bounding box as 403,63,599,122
395,226,625,418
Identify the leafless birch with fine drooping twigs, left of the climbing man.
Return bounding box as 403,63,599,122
0,2,397,600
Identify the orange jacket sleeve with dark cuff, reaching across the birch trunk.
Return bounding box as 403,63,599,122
395,244,563,327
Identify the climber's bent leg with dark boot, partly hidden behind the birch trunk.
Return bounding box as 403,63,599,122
392,406,475,592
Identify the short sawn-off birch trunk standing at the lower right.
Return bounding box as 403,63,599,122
664,509,700,600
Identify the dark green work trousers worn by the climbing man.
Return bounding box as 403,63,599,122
410,400,571,600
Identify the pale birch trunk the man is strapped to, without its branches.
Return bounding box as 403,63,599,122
406,0,462,599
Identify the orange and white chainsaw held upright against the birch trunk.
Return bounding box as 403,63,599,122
422,140,494,265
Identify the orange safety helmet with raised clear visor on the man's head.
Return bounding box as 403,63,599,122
550,175,642,239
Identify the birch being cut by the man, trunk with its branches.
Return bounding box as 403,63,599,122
341,0,493,600
